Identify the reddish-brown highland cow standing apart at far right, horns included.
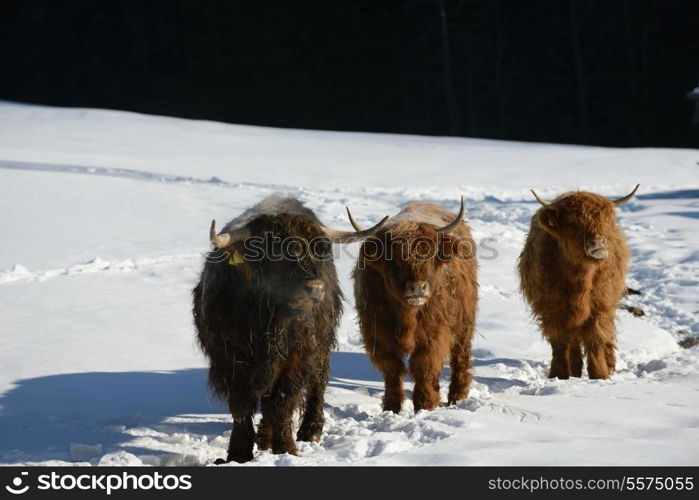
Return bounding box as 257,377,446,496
519,186,638,379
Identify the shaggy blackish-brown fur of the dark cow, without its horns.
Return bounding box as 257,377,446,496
193,198,342,462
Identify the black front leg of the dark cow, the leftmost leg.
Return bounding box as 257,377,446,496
228,384,257,462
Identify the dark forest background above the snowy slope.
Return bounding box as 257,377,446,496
0,0,699,147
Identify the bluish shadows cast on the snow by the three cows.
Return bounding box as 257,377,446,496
0,352,532,463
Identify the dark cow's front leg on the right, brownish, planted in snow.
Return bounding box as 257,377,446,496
269,368,300,455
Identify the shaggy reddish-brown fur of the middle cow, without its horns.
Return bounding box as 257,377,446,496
352,203,478,413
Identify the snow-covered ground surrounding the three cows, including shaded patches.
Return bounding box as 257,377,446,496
0,103,699,465
